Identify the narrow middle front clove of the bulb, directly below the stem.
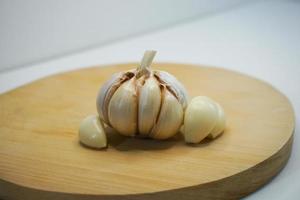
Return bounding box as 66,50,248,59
138,77,161,136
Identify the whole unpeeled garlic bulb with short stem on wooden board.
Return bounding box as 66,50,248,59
96,51,187,139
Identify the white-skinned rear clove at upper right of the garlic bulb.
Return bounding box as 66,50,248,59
155,71,188,109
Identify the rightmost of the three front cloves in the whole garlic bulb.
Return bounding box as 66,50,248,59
150,87,183,139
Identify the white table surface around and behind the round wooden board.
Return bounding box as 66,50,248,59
0,0,300,200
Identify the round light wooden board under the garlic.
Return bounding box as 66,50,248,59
0,63,294,200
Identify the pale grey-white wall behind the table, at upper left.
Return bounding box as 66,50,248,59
0,0,245,70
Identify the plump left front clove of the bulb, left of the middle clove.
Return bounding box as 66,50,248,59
108,78,137,136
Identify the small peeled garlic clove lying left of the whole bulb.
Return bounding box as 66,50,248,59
79,115,107,148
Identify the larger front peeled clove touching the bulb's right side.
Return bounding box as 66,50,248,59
184,96,218,143
